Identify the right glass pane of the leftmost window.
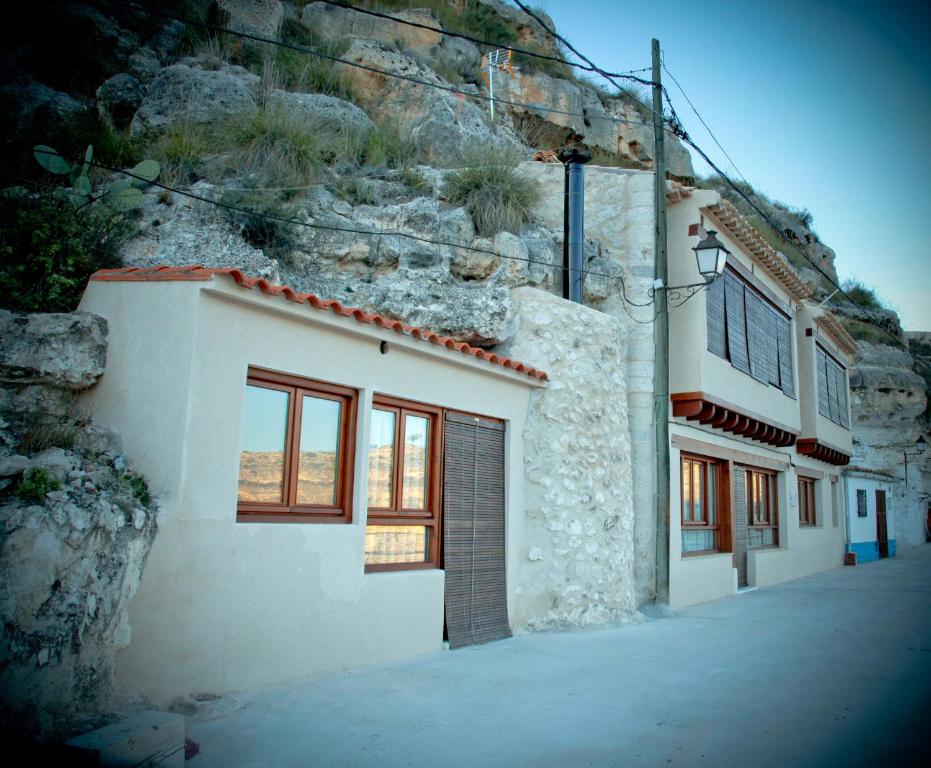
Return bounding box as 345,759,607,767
297,395,343,507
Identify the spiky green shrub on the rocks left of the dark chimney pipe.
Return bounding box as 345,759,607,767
445,144,540,236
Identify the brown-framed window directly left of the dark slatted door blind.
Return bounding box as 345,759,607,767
365,396,441,571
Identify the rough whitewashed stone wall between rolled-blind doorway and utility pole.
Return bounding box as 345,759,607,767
501,288,639,630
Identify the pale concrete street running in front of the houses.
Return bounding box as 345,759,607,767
188,545,931,768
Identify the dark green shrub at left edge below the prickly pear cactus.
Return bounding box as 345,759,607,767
0,189,135,312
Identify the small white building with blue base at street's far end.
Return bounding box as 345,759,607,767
844,467,902,563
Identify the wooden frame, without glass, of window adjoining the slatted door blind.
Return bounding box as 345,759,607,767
365,394,443,573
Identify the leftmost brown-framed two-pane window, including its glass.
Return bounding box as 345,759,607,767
237,368,357,522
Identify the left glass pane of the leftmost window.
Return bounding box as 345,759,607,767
239,384,289,504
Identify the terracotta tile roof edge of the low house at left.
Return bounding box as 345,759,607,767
90,264,549,381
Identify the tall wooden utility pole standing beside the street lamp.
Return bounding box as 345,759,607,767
653,38,669,603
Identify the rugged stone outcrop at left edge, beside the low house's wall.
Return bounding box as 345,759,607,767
0,312,156,739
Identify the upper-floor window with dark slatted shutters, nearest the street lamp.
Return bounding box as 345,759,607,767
707,269,795,397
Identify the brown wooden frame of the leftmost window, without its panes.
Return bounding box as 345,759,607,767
236,366,359,523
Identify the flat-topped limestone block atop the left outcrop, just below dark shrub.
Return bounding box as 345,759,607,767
0,310,107,390
